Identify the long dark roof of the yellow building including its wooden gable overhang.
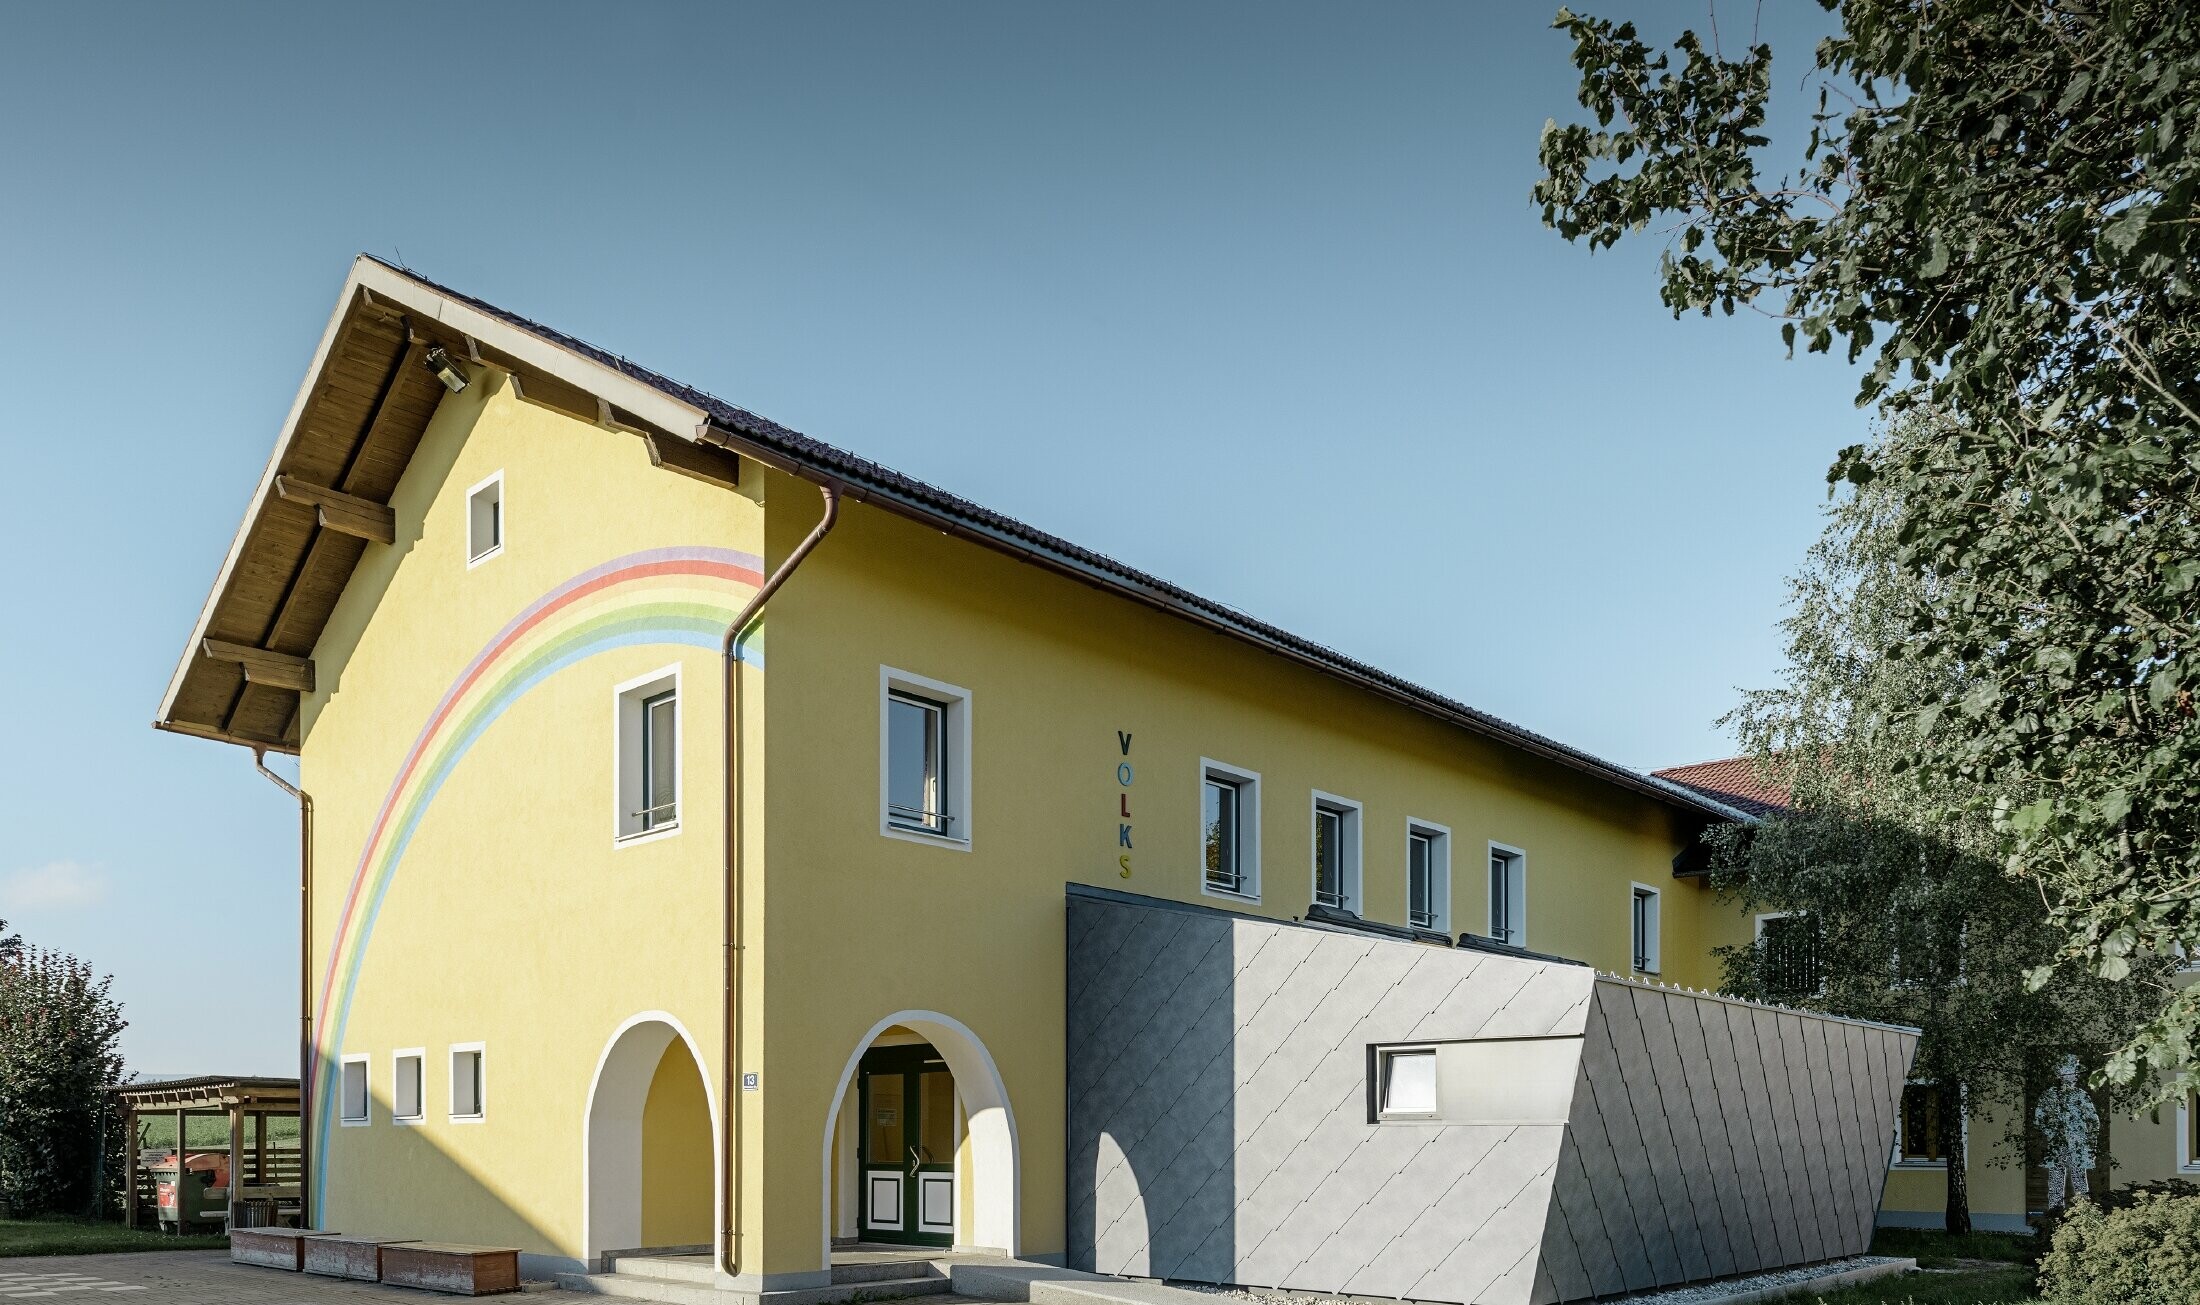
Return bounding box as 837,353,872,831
154,255,1749,821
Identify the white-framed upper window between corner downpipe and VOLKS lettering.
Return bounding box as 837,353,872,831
878,667,970,852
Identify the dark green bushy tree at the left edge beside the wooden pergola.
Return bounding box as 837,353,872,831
0,946,125,1215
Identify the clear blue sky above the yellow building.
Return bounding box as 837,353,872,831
0,0,1866,1072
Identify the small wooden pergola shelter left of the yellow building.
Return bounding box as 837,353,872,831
112,1074,306,1228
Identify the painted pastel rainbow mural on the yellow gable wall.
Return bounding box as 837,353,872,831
306,539,763,1210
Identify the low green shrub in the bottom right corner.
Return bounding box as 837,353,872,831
2039,1191,2200,1305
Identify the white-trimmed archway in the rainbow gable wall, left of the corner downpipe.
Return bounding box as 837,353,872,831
581,1010,717,1268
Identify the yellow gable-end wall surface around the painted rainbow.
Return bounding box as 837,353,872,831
299,372,761,1254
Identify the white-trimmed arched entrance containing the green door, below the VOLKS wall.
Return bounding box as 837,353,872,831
821,1010,1021,1263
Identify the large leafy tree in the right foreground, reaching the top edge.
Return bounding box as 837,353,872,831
1533,0,2200,1096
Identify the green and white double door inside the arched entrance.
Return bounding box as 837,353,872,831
856,1043,955,1246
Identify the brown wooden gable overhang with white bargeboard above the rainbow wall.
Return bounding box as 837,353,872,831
154,257,737,753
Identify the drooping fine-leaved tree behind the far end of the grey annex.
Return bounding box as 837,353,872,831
1712,420,2174,1232
